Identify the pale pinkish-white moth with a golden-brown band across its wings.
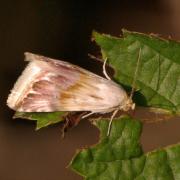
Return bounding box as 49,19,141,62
7,52,140,134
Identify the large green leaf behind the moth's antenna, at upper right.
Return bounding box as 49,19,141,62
93,30,180,113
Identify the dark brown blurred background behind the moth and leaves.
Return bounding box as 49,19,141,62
0,0,180,180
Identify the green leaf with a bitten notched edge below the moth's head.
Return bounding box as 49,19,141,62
70,117,180,180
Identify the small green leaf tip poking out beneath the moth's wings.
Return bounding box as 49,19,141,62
14,112,66,130
